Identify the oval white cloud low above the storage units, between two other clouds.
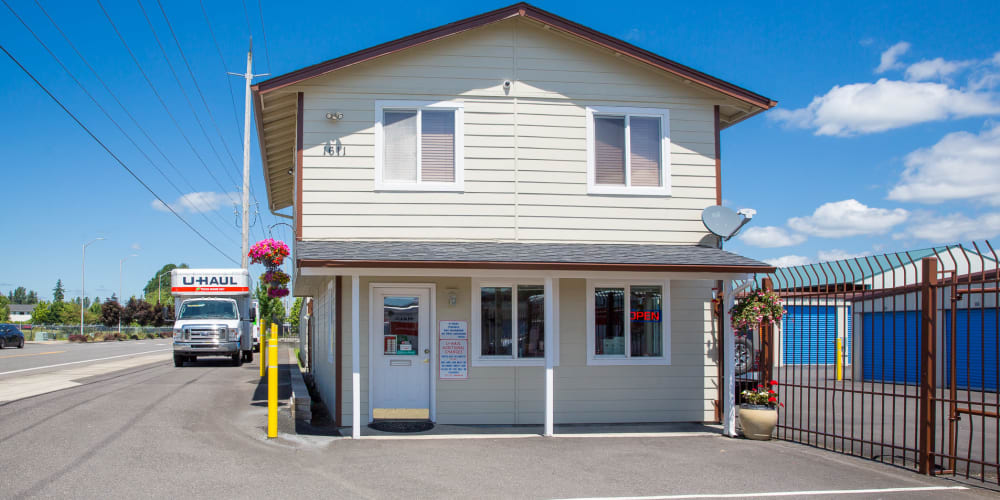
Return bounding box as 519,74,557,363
788,199,910,238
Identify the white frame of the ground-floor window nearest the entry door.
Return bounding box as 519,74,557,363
469,278,559,366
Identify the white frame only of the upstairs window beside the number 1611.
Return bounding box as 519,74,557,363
375,101,465,192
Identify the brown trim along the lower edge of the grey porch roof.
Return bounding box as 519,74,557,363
296,259,775,273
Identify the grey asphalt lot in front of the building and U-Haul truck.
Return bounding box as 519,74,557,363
0,348,996,498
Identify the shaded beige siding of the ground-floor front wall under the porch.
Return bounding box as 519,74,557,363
332,277,717,425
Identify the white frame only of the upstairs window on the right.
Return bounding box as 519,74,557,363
587,106,671,196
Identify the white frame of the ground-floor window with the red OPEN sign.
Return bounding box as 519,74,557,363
587,280,671,366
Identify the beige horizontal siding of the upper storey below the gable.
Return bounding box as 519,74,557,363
292,19,723,244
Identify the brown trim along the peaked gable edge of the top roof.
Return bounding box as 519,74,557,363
253,2,777,109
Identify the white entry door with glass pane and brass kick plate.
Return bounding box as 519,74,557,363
370,287,432,419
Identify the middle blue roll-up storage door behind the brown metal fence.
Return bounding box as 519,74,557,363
861,311,920,384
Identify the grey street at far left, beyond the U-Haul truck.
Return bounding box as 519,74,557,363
0,339,170,381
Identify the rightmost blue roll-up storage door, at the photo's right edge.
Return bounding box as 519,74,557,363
943,309,998,391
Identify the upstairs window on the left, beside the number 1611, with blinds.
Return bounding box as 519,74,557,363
375,101,463,191
